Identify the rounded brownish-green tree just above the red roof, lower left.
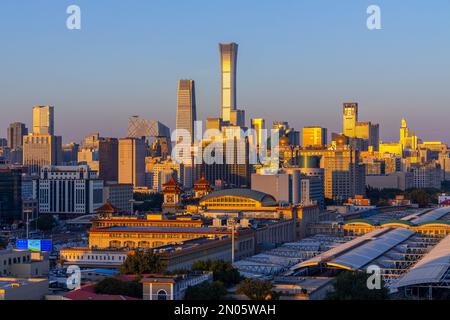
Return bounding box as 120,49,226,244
120,251,166,275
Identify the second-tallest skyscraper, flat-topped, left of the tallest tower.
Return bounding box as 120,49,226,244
176,80,197,143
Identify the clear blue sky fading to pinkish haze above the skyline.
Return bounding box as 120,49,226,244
0,0,450,143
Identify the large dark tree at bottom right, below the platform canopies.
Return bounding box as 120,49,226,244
326,271,389,300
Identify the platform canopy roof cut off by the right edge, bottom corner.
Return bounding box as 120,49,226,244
395,235,450,288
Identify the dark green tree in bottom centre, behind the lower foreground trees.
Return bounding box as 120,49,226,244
192,260,242,287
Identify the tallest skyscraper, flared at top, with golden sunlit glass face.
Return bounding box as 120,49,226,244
219,43,238,122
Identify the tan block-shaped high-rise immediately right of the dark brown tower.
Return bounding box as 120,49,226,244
119,138,145,187
